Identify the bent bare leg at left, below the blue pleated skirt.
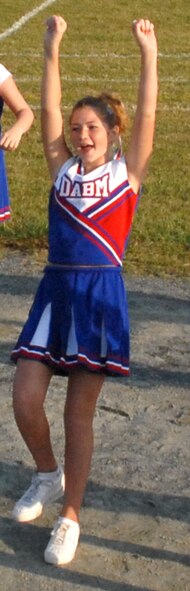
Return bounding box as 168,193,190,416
13,359,57,472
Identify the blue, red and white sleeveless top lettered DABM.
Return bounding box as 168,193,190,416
49,156,138,266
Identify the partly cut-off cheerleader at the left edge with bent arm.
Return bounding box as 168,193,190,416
0,64,34,222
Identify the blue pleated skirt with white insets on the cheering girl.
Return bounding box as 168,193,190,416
11,266,129,376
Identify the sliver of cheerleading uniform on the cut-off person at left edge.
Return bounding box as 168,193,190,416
0,64,11,222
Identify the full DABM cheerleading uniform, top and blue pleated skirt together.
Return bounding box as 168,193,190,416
12,155,138,375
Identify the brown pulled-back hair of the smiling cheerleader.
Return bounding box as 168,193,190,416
69,93,128,134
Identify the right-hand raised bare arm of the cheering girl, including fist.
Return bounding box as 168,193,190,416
126,19,157,192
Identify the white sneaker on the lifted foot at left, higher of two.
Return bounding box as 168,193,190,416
12,468,65,523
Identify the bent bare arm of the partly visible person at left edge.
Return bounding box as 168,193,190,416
0,76,34,151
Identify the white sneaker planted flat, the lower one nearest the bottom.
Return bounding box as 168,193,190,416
44,517,80,565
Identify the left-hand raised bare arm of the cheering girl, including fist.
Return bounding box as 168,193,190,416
41,16,70,181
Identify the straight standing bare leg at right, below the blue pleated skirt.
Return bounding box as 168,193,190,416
61,369,104,521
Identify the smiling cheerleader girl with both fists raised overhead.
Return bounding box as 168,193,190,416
12,16,157,564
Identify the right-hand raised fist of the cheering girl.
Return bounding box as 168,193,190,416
132,19,157,54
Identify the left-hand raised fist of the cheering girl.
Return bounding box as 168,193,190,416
44,15,67,52
